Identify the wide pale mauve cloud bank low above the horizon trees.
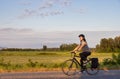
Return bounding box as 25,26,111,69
0,28,120,48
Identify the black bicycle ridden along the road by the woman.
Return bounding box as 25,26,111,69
62,53,99,76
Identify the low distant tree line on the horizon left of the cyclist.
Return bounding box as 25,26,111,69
1,43,77,51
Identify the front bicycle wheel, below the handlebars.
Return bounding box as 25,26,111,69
62,59,78,76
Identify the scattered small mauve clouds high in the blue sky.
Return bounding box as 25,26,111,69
17,0,72,19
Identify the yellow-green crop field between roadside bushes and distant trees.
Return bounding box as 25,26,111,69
0,51,115,64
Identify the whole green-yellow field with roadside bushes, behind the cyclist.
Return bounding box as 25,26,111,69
0,51,118,70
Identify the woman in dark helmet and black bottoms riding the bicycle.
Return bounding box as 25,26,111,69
72,34,91,69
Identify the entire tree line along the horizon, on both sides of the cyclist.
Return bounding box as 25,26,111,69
2,36,120,52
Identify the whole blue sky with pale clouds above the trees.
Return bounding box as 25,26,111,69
0,0,120,48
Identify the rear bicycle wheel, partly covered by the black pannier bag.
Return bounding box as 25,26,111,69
86,61,99,75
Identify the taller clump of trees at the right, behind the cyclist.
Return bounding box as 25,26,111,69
96,36,120,52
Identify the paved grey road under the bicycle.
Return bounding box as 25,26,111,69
0,70,120,79
